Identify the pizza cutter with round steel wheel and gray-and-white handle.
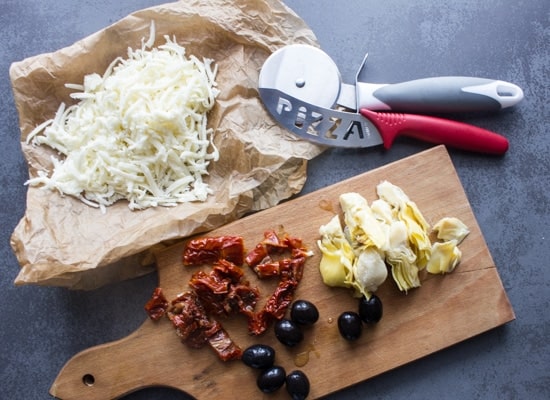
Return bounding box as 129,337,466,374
259,44,523,114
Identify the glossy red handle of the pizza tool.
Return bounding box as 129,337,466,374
360,108,508,155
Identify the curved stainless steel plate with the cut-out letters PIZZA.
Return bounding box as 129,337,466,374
259,87,383,148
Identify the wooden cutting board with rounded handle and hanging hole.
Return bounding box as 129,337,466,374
50,146,515,400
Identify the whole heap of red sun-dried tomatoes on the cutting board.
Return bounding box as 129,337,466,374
151,230,309,361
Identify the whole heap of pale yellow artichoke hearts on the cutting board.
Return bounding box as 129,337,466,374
317,181,470,299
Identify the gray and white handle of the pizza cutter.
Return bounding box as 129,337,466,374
357,76,523,113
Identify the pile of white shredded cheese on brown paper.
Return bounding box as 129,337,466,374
27,24,219,212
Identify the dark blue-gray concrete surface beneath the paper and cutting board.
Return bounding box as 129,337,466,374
0,0,550,400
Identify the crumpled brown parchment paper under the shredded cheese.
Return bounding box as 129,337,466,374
10,0,322,289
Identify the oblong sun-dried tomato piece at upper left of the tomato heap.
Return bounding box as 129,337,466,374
183,236,244,265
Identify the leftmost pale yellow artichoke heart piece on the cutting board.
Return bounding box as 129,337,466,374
317,215,355,287
